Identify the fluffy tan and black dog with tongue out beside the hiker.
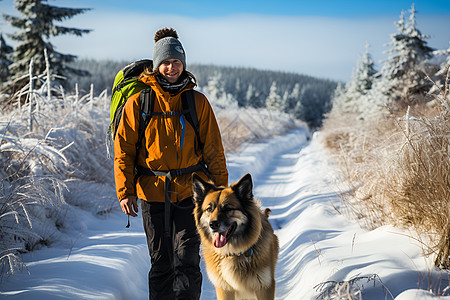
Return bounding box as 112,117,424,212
193,174,279,300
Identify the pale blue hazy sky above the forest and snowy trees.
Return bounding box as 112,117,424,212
0,0,450,81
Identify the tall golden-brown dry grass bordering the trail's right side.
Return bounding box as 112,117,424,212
323,69,450,269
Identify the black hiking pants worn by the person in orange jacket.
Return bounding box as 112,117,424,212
141,198,202,300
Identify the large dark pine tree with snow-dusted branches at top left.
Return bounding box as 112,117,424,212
3,0,91,87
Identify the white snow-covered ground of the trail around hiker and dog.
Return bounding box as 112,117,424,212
0,128,450,300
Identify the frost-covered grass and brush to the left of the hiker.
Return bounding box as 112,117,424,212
0,85,115,282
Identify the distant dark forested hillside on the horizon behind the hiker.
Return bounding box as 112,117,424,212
69,59,337,127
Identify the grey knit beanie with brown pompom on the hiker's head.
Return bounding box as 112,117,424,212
153,28,186,70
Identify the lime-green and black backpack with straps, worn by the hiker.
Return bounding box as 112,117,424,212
106,59,203,158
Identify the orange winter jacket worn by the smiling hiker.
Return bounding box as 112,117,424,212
114,76,228,202
